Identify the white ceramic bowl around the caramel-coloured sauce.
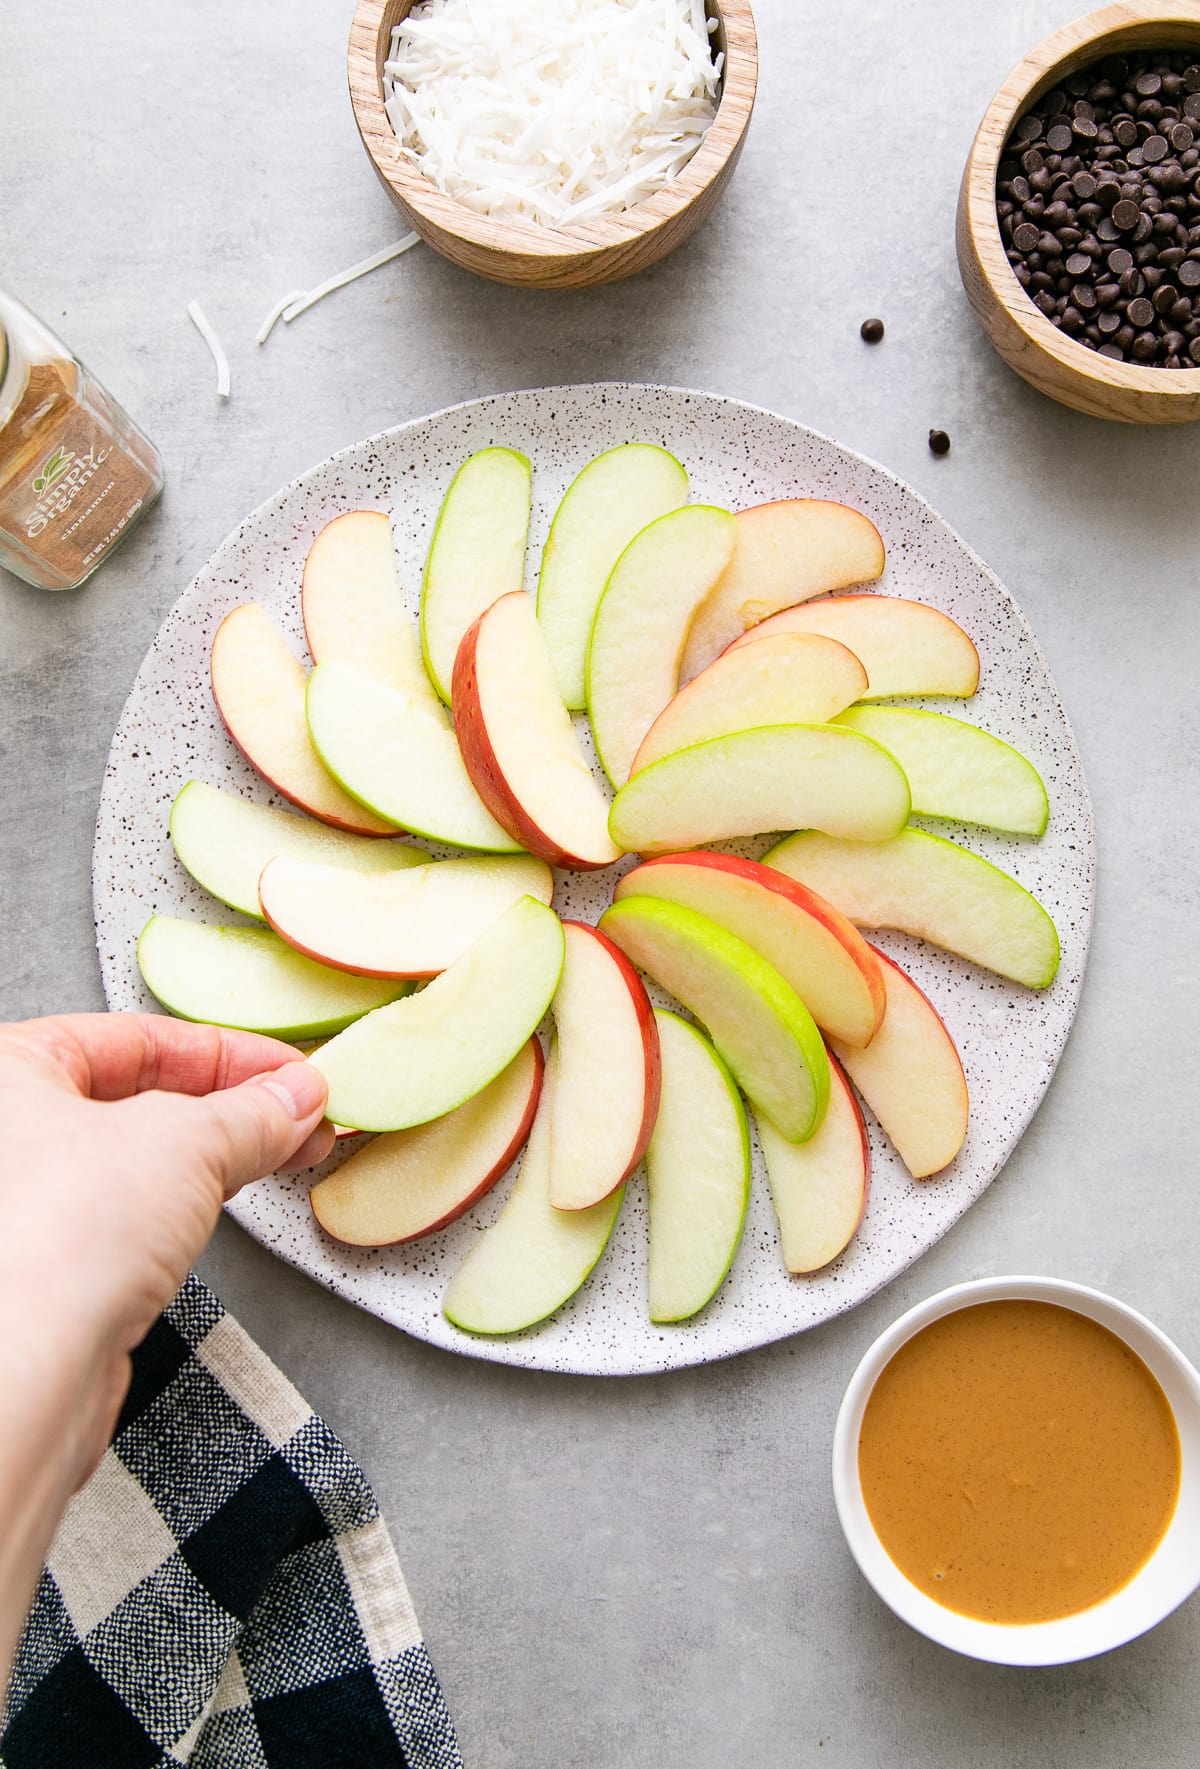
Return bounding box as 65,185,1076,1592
834,1277,1200,1665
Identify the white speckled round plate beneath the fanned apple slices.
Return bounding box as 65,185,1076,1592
94,384,1094,1376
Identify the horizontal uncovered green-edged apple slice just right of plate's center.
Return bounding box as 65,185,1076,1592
609,725,908,854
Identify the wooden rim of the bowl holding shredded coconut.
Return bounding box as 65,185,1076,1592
349,0,758,264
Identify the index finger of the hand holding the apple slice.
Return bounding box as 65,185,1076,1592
11,1014,301,1100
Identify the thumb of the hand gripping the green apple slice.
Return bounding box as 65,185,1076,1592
196,1063,329,1198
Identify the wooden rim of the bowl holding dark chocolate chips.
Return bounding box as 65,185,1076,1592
965,0,1200,398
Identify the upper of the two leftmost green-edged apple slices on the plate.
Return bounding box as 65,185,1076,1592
170,780,432,920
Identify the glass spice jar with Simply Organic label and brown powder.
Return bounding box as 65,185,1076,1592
0,290,163,589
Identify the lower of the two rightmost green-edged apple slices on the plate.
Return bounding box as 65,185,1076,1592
763,830,1058,989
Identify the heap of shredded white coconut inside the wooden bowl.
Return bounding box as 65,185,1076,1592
384,0,724,226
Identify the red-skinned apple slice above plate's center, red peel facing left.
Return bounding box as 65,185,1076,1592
455,591,619,870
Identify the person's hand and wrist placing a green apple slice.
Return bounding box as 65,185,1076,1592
0,1014,333,1689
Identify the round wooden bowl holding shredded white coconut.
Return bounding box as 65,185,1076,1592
349,0,758,288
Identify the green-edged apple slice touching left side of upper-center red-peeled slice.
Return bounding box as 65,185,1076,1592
308,663,520,854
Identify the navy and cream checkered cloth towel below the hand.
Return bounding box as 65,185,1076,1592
0,1277,462,1769
